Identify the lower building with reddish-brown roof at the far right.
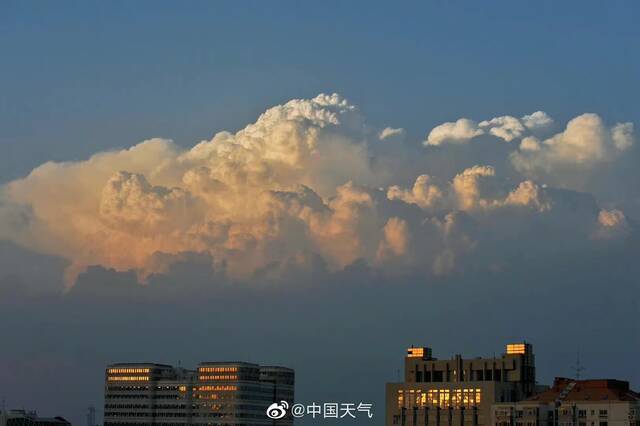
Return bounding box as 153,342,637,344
491,377,640,426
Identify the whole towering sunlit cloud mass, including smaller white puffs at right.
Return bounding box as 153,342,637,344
0,94,633,283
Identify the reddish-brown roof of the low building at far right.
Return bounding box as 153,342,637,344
526,377,640,403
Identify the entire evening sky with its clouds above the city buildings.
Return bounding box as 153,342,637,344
0,1,640,424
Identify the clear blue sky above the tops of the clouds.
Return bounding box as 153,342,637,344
0,1,640,181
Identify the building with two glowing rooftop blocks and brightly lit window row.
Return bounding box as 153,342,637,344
385,343,536,426
